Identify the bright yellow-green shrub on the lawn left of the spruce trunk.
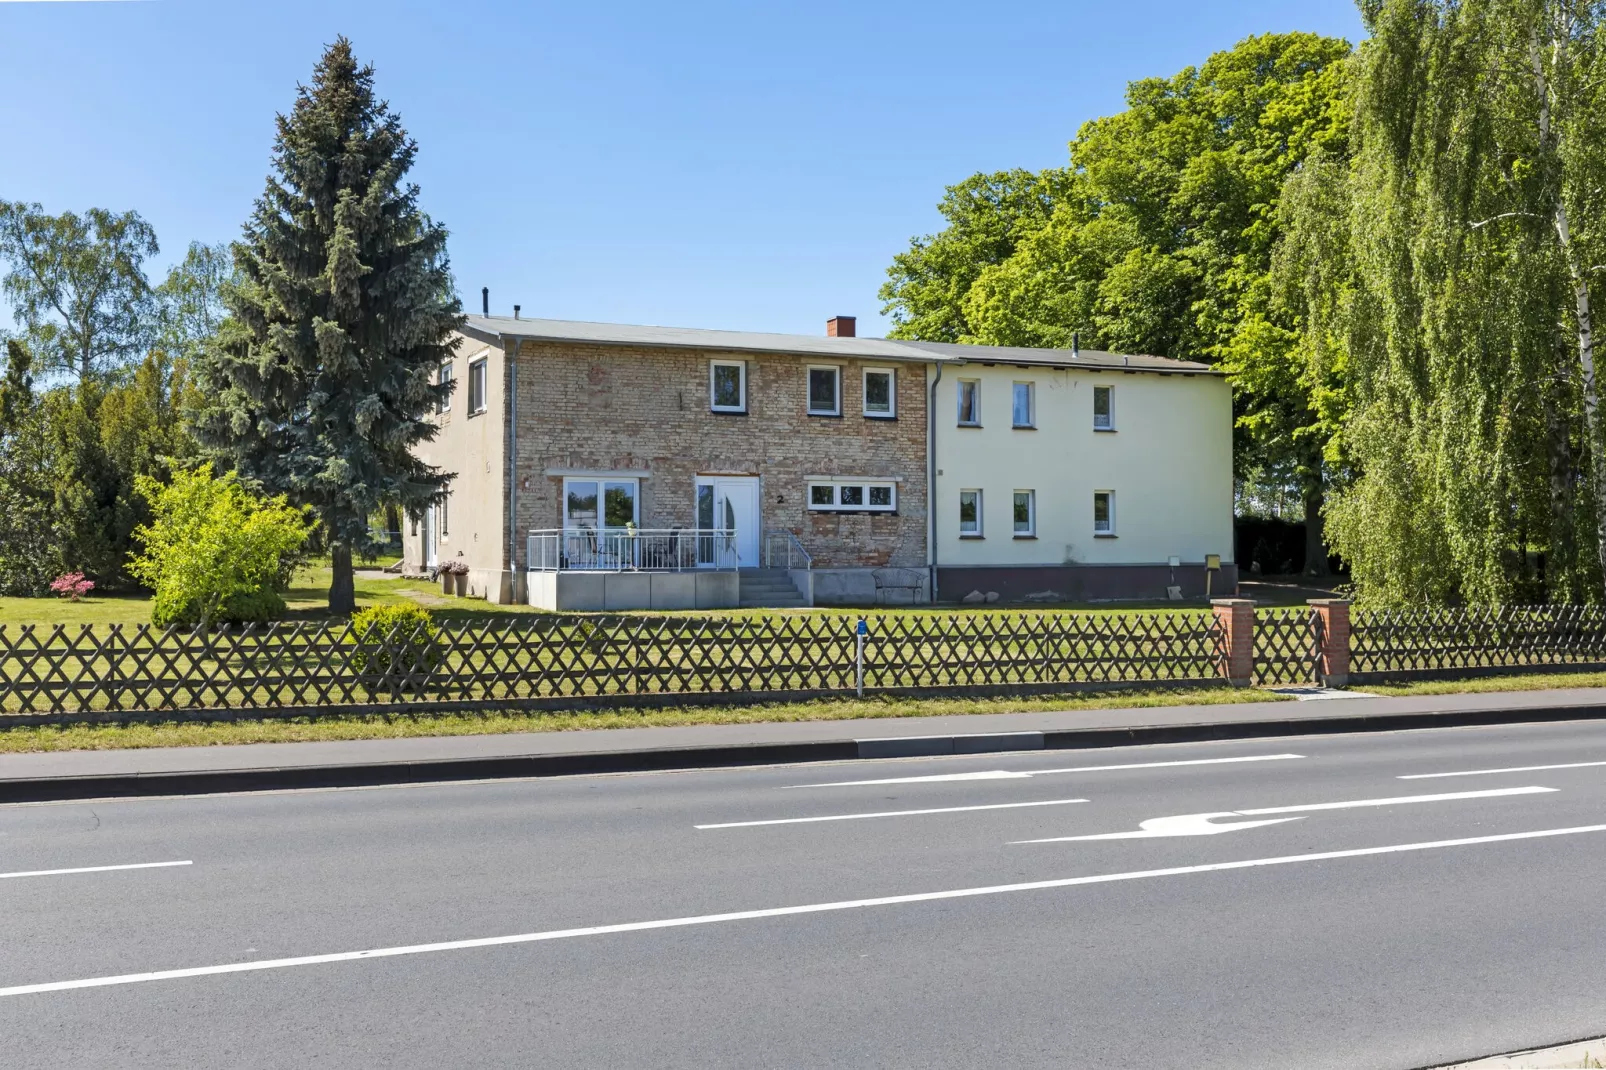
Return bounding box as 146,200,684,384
128,464,307,628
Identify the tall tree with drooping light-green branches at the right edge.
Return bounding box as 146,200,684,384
1304,0,1606,604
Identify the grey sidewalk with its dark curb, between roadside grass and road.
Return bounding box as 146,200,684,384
0,688,1606,802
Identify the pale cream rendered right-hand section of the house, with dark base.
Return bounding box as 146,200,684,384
935,350,1237,601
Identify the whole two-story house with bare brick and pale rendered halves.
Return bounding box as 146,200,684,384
403,315,1235,609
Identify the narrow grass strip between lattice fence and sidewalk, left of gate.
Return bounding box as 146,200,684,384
0,688,1288,753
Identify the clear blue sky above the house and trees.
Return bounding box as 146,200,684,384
0,0,1362,334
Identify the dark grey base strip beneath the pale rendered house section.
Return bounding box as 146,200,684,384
936,562,1238,604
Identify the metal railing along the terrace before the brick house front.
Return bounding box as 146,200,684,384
525,527,739,572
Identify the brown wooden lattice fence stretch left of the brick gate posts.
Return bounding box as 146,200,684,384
0,612,1221,715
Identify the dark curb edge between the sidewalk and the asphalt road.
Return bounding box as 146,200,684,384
0,704,1606,803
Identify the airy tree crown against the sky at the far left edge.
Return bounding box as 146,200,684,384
0,201,157,386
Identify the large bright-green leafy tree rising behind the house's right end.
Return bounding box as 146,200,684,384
882,34,1351,572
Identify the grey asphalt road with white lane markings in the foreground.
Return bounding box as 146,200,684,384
0,723,1606,1068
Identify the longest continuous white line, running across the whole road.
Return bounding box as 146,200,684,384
0,824,1606,996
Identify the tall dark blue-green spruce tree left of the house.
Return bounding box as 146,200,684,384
194,37,463,612
